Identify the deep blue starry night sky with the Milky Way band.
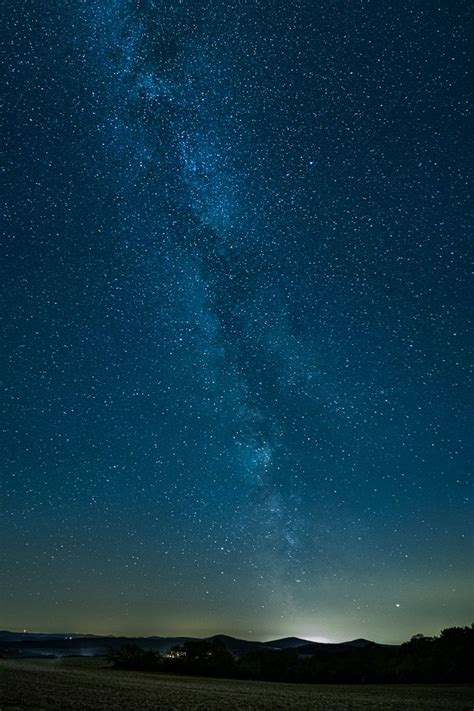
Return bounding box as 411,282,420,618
0,0,474,642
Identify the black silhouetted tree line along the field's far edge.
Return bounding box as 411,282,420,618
109,625,474,684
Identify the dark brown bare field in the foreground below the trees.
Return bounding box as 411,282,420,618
0,658,474,711
